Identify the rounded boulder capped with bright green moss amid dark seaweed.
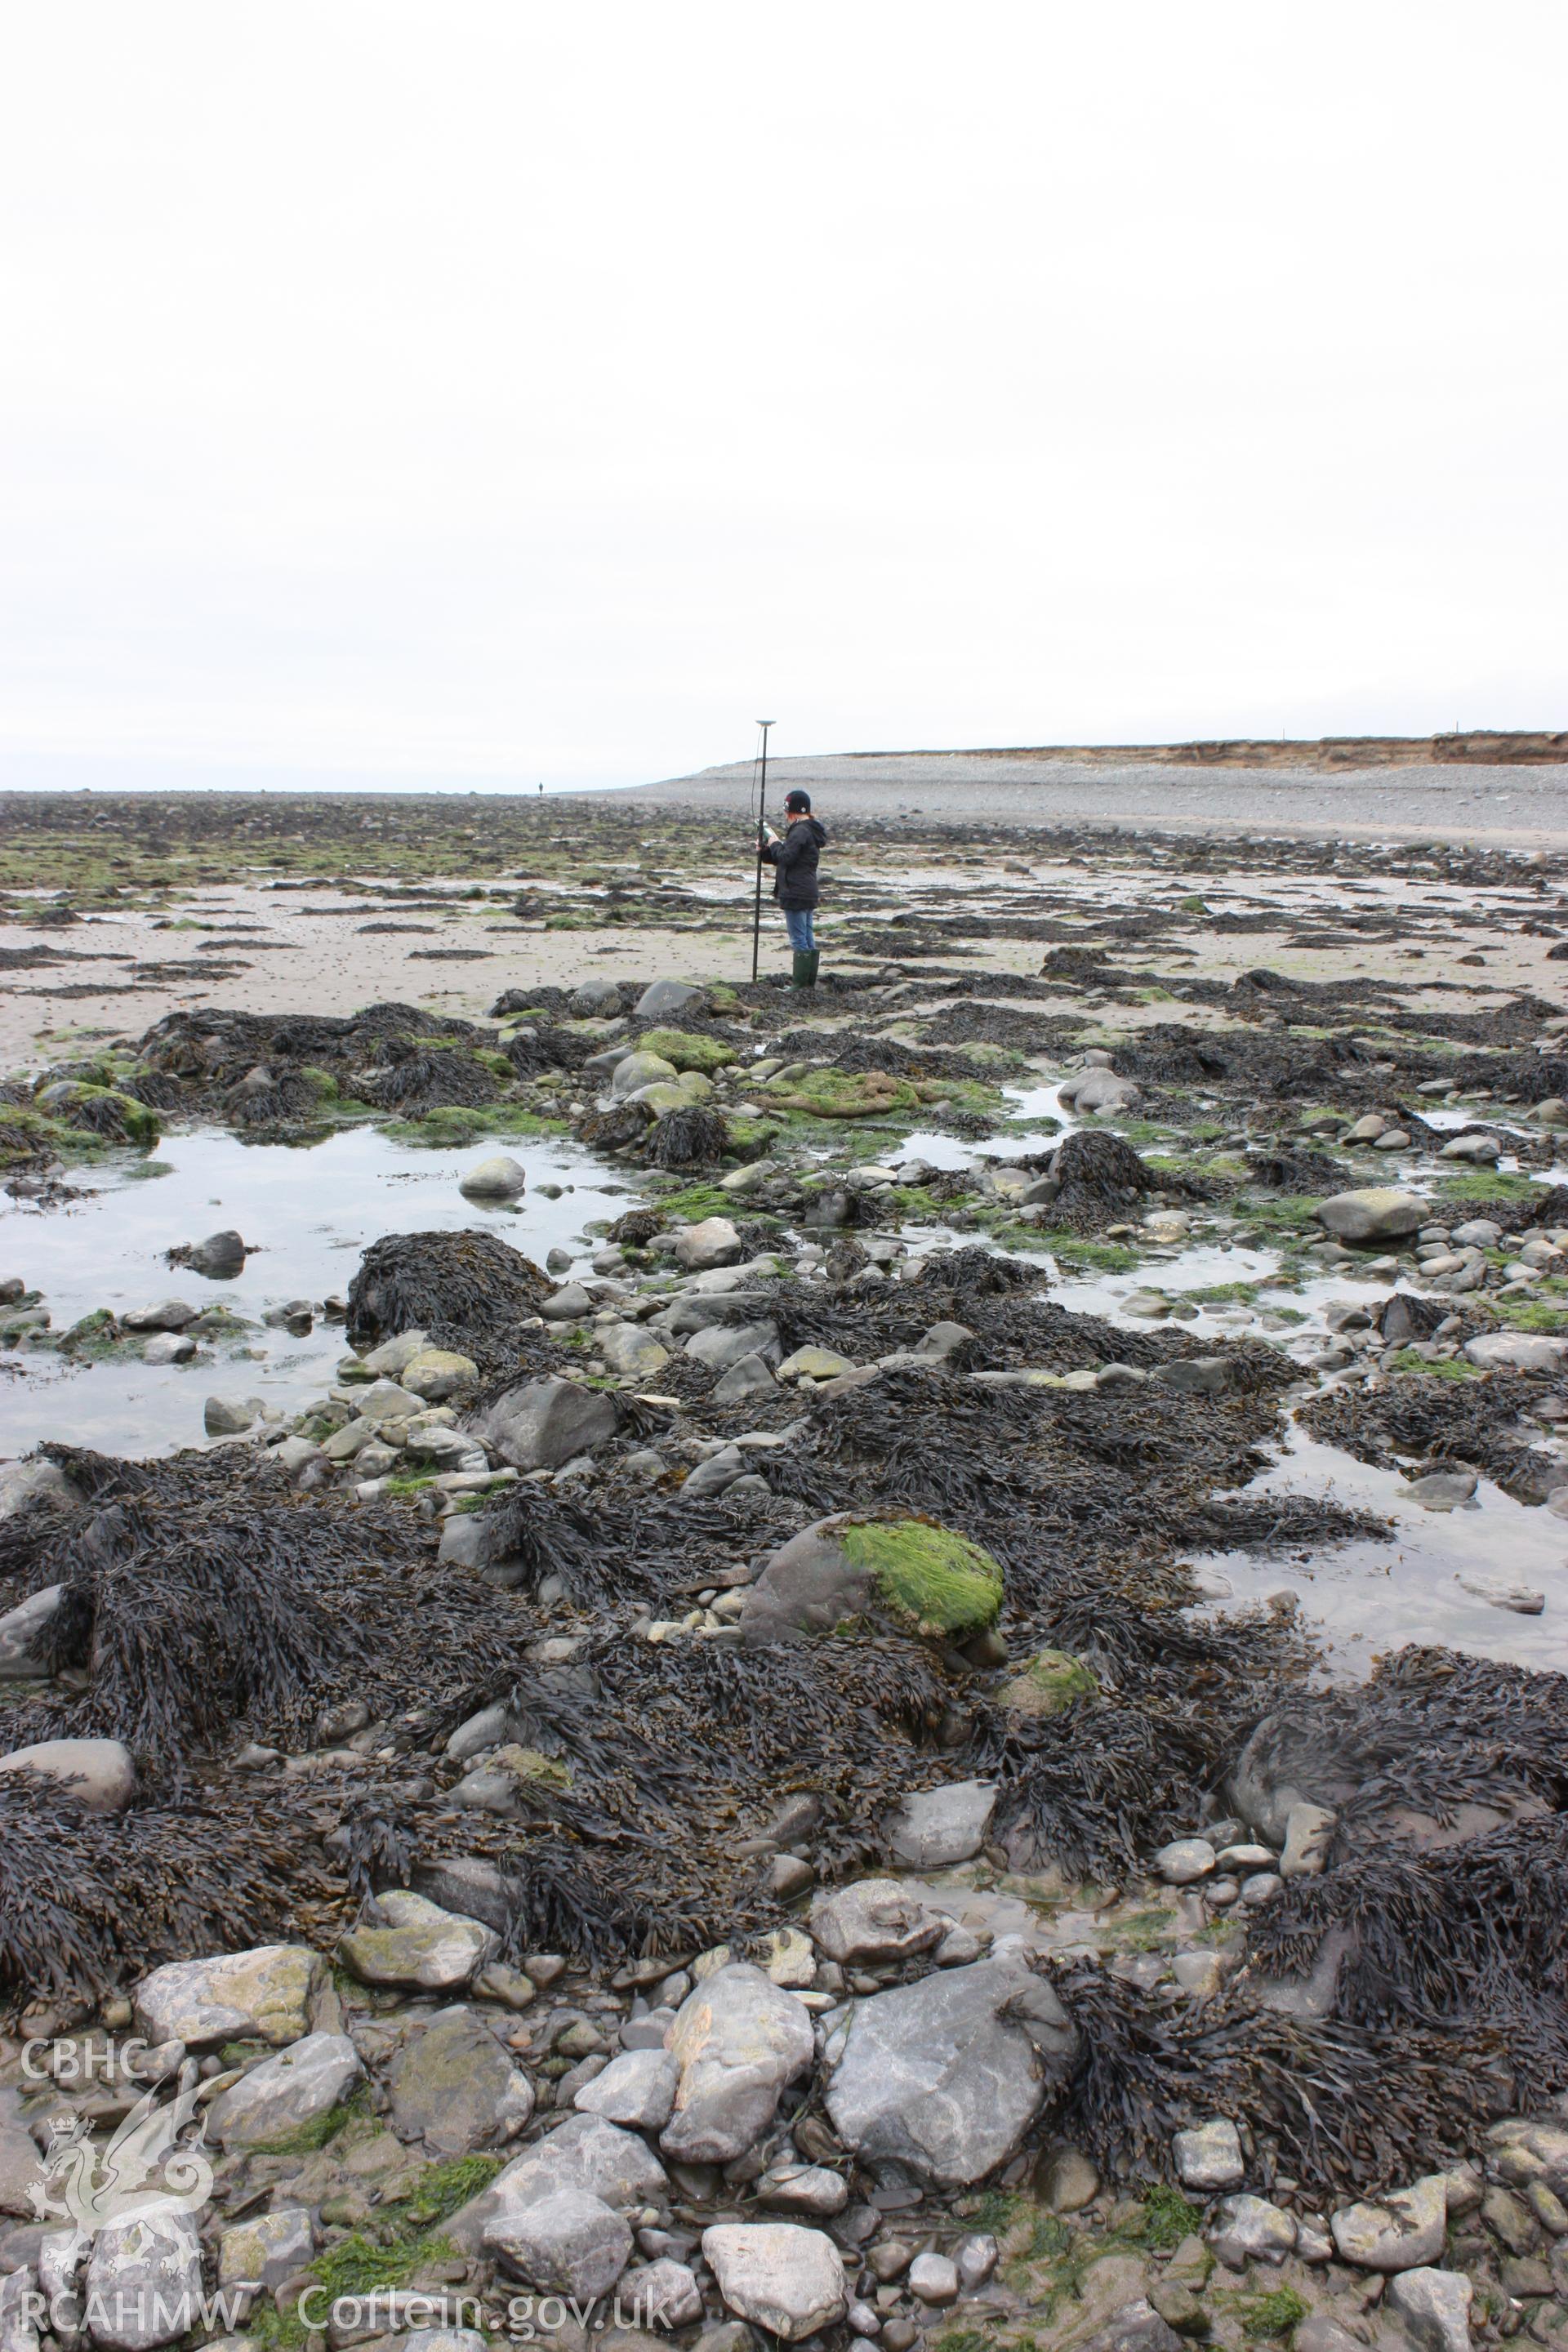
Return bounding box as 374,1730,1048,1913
741,1517,1001,1642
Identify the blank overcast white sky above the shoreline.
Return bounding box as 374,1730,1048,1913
0,0,1568,788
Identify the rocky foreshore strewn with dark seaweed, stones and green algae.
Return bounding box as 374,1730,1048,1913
0,818,1568,2352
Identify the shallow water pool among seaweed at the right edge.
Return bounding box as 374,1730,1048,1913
1194,1425,1568,1682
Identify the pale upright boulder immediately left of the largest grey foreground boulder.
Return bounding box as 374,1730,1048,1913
658,1962,816,2164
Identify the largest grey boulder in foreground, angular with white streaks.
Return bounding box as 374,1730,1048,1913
825,1959,1076,2187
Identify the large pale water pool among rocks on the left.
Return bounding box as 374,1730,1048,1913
0,1127,628,1456
